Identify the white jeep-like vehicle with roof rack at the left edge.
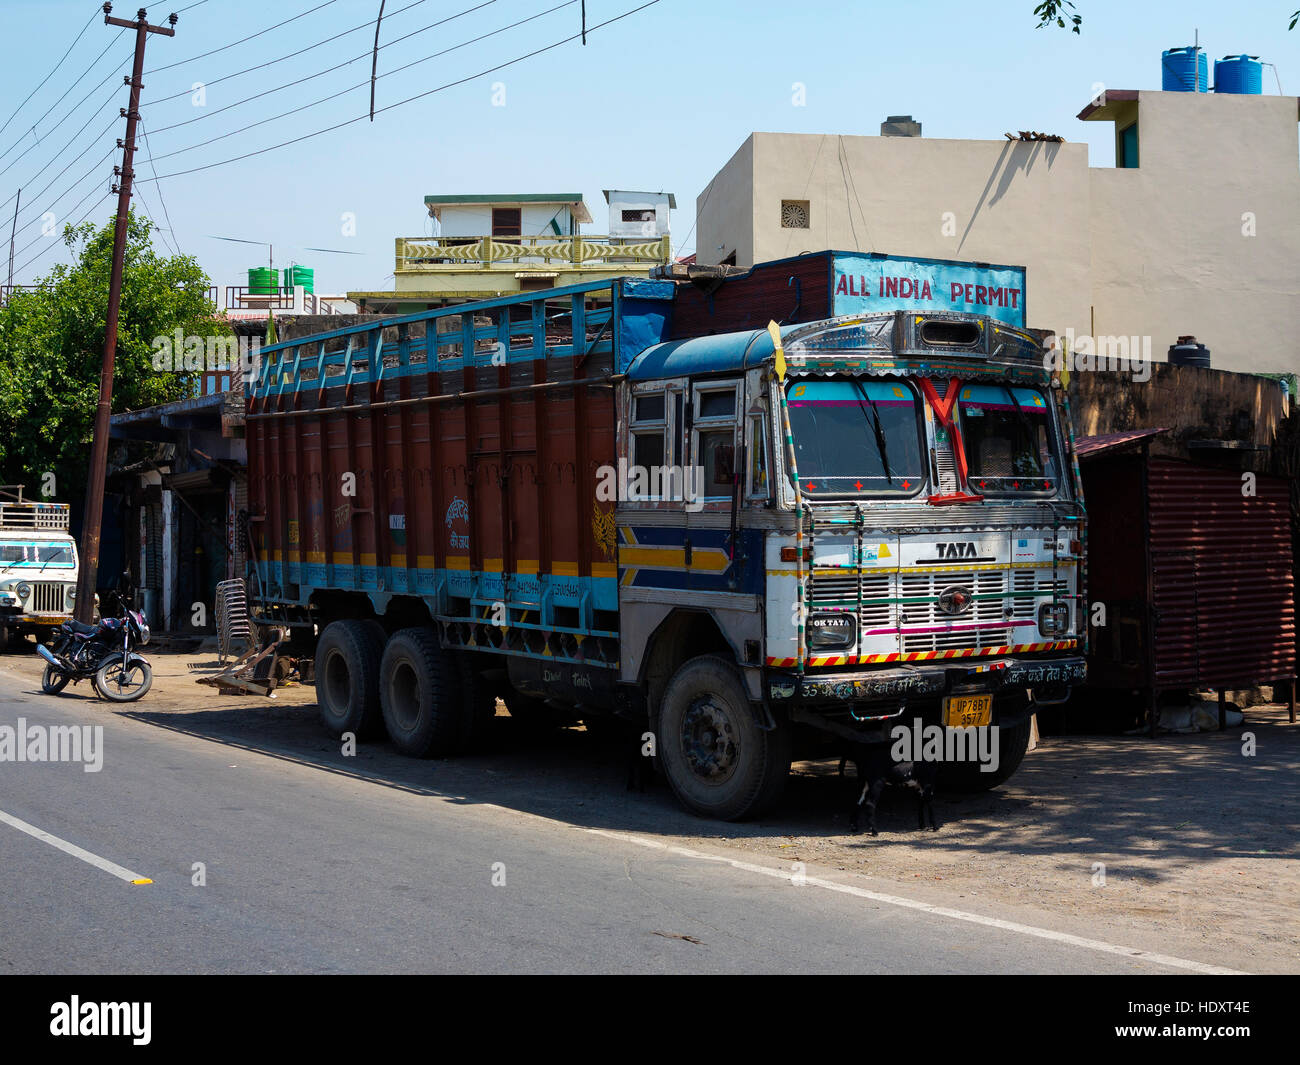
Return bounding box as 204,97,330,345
0,485,77,646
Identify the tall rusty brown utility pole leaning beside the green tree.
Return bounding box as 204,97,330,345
75,4,177,623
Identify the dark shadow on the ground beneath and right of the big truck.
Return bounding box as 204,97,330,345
121,689,1300,883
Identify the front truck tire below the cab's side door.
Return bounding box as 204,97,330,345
655,654,790,821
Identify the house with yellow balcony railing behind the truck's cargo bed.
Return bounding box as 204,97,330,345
347,191,676,313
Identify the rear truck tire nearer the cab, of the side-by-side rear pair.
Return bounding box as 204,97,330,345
380,627,465,758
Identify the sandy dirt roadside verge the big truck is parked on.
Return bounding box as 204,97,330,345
0,653,1300,971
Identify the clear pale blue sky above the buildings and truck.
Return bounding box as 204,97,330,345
0,0,1300,293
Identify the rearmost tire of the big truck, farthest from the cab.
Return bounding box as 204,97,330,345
315,618,384,740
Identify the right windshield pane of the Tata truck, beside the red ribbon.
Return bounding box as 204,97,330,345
958,385,1060,494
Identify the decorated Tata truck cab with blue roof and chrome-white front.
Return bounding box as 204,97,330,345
618,311,1086,817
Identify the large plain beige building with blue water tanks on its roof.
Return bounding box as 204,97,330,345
697,90,1300,373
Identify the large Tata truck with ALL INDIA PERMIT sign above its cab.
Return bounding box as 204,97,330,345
246,255,1087,821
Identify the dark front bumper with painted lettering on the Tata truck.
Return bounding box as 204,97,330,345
766,655,1088,722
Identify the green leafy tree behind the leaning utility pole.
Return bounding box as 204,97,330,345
0,213,231,503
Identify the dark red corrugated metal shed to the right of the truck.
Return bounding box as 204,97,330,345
1078,429,1296,712
